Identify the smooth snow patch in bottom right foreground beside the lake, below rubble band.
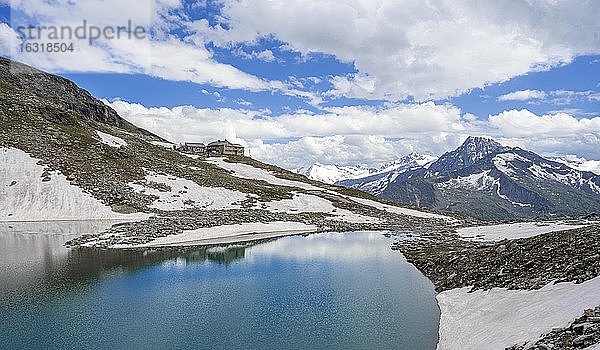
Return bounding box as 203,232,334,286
437,277,600,350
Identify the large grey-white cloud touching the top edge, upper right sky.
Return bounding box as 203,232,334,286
197,0,600,100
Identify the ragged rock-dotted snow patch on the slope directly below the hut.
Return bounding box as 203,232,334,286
129,172,247,211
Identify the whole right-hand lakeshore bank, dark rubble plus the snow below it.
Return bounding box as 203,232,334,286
392,221,600,350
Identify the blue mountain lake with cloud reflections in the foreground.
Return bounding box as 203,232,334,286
0,227,439,350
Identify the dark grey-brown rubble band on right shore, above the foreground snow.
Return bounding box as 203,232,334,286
393,225,600,292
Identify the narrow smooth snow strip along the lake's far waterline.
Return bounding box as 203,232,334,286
113,221,317,248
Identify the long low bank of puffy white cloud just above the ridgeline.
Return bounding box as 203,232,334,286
110,100,600,168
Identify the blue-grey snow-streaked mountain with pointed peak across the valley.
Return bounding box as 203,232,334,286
302,137,600,220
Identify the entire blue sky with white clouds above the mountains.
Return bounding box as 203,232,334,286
0,0,600,168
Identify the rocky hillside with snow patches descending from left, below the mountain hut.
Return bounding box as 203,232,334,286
0,58,456,247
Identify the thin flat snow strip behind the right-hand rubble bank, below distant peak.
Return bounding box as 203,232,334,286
456,221,588,241
